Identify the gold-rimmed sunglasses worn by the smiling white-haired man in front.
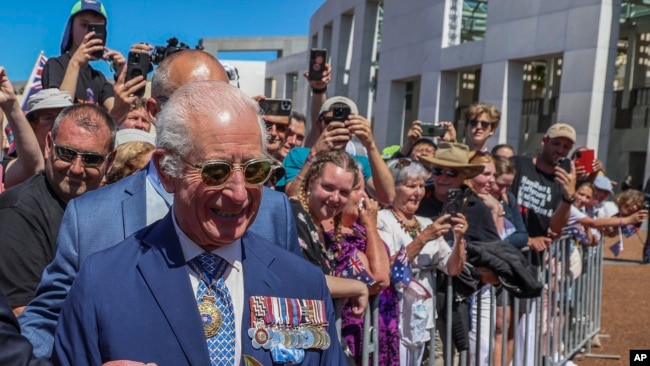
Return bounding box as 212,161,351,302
183,158,277,188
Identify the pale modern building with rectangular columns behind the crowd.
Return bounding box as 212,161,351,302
265,0,650,192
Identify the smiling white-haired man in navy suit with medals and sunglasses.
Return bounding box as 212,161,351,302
53,81,346,365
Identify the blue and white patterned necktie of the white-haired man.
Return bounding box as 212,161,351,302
192,252,236,366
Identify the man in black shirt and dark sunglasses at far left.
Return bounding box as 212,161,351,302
0,104,115,315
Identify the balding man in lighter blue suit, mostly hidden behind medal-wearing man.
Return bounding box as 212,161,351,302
19,50,300,357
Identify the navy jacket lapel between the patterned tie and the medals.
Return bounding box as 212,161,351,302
241,234,282,361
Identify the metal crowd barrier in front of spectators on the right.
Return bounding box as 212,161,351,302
337,234,603,366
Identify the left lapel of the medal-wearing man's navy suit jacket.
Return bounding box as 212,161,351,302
138,212,210,365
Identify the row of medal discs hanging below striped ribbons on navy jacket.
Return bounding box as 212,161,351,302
248,324,331,350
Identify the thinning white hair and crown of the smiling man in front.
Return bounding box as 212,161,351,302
156,81,267,178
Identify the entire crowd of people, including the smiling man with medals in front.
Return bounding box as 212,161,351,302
0,0,650,365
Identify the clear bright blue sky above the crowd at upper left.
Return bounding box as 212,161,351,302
0,0,324,81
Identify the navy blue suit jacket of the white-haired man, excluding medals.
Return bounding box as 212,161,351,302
53,214,345,366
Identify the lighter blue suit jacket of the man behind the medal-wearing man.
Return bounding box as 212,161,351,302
18,170,302,357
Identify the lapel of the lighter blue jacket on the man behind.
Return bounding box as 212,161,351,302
122,170,147,238
